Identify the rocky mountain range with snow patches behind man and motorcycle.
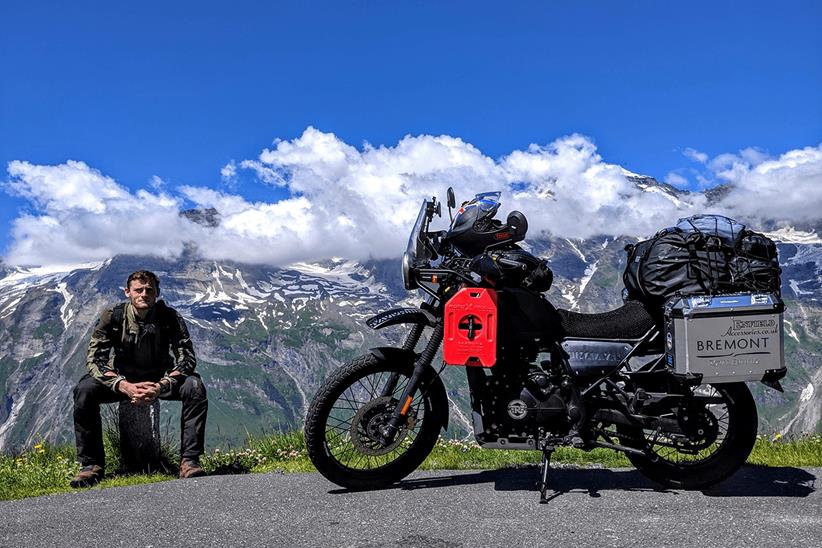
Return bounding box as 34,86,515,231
0,178,822,451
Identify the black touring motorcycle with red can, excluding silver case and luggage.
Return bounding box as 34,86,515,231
305,188,785,502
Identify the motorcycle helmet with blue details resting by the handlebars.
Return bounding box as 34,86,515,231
445,192,528,257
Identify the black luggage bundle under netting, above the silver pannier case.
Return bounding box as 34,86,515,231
623,215,781,305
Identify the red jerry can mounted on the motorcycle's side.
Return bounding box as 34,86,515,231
442,287,497,367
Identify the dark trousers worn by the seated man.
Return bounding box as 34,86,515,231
74,373,208,467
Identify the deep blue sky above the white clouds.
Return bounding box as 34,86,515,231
0,0,822,261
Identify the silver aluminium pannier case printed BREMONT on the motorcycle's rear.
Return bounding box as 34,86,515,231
664,293,785,383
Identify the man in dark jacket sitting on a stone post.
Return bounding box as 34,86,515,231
71,270,208,487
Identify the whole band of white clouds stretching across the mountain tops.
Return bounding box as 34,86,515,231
1,128,822,265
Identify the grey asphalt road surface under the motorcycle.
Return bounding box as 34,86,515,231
0,467,822,548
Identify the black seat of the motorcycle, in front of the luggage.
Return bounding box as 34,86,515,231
557,300,656,341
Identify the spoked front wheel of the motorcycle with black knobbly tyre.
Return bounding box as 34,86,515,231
305,354,448,489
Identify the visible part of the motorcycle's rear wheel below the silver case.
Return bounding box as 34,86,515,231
620,382,758,489
